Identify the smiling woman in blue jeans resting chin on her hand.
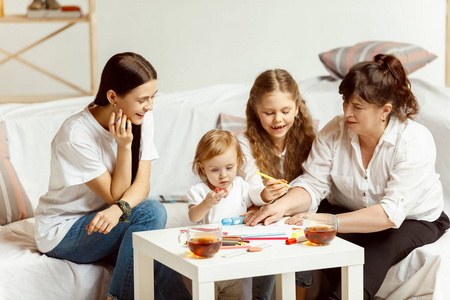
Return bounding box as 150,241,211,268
36,53,190,300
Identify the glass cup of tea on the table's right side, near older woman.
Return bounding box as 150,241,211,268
303,213,337,245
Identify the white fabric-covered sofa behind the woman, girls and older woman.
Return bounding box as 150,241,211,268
0,78,450,300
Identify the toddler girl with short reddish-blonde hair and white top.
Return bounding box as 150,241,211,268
187,129,251,299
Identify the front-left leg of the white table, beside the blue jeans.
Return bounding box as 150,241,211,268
133,249,155,300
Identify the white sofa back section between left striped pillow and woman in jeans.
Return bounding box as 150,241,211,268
1,96,92,209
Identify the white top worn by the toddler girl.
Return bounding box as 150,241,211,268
187,176,252,224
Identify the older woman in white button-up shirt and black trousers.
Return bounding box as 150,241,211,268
247,54,449,299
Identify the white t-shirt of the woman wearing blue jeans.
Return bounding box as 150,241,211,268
35,107,158,252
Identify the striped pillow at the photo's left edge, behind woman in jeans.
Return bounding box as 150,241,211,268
0,122,33,225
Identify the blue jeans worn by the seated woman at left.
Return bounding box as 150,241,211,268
45,200,191,300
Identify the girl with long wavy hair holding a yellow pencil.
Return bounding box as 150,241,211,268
239,69,315,299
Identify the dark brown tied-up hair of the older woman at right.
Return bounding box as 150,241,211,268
339,54,419,122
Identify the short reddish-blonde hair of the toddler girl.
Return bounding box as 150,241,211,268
192,129,245,182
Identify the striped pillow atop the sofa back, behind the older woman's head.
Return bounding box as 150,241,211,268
319,41,437,79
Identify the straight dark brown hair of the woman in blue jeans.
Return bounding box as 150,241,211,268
94,52,157,182
